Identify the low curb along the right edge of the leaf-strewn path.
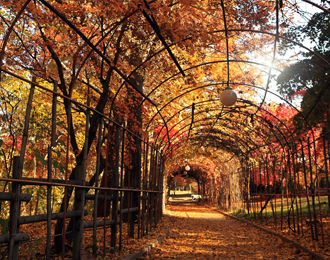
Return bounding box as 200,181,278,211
211,208,326,260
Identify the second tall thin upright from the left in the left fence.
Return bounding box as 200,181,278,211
46,81,57,259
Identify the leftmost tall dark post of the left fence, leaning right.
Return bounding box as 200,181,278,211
8,77,36,259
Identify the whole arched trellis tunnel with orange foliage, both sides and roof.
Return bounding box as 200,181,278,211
0,0,330,259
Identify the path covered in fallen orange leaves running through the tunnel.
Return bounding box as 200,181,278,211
139,204,313,260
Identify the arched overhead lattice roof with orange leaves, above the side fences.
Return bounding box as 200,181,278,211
1,0,329,177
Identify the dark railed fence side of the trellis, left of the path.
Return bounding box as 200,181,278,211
0,76,164,259
